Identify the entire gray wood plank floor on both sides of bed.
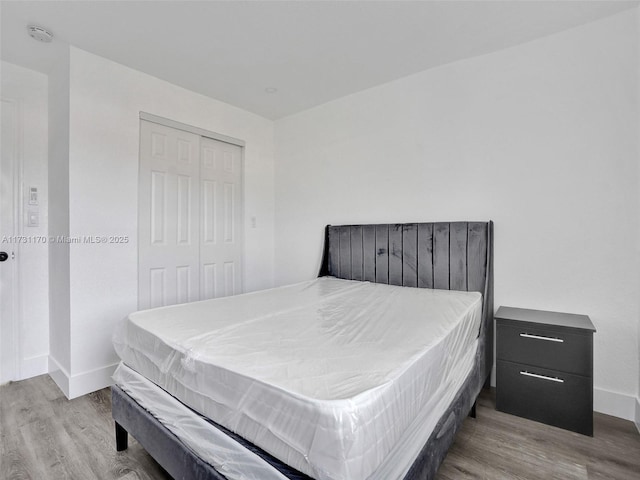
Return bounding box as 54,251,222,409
0,376,640,480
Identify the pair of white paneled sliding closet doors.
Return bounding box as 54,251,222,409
138,120,243,309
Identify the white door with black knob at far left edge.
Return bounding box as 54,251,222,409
0,99,19,384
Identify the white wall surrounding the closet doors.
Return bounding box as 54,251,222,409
53,47,274,397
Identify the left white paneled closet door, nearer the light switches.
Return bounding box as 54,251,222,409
139,121,200,309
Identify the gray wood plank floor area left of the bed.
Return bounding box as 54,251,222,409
0,375,171,480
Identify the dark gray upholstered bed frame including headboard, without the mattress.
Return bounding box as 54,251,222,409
111,222,493,480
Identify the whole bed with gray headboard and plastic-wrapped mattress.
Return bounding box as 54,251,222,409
112,222,493,480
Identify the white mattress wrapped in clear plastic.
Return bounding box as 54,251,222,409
114,277,482,480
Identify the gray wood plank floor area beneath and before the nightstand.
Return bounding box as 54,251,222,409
437,391,640,480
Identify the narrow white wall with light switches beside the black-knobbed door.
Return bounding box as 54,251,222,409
1,61,49,379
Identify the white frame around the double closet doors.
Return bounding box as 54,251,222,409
137,112,246,308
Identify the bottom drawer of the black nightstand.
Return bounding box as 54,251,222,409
496,360,593,435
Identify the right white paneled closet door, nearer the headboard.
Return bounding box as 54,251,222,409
200,137,243,300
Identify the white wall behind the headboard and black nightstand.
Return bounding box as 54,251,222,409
275,10,640,418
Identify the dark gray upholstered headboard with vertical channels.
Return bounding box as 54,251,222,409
320,221,493,379
